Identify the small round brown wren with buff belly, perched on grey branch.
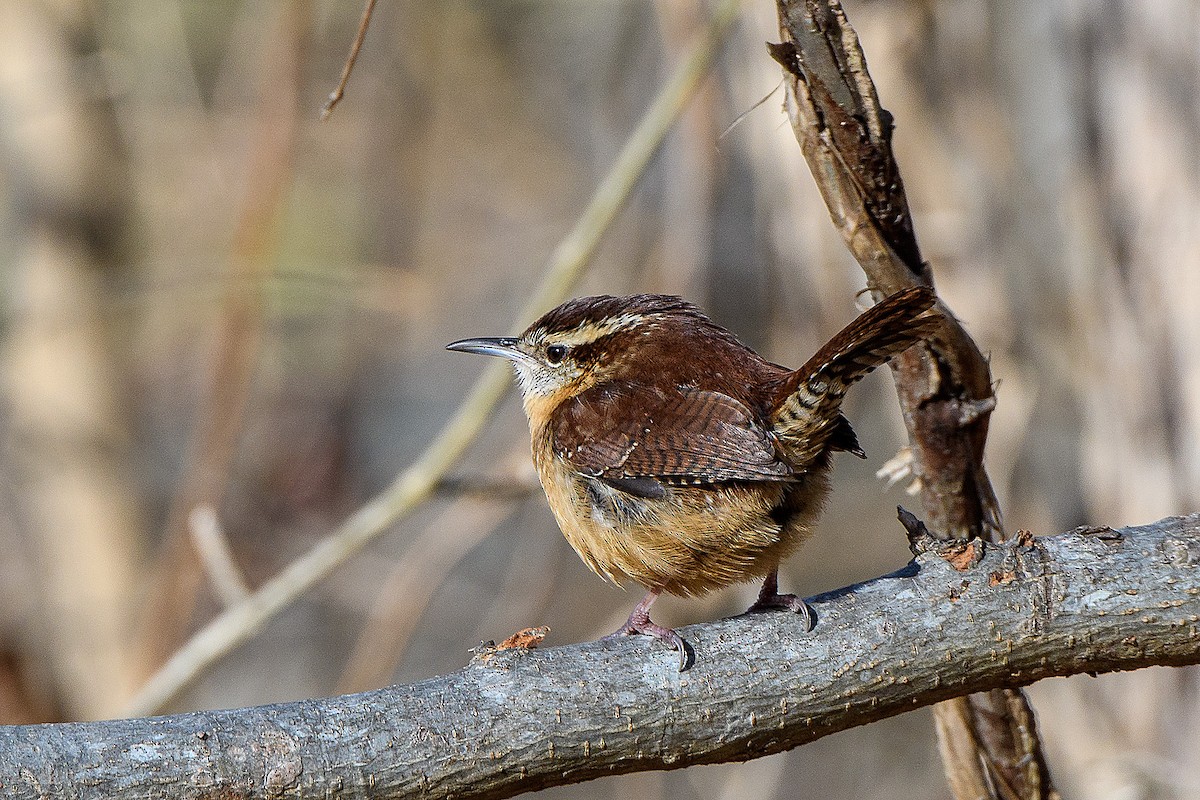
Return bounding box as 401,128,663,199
446,287,936,669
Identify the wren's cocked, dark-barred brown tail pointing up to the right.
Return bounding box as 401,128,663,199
772,287,937,470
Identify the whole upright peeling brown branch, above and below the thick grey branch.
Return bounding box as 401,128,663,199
770,0,1057,800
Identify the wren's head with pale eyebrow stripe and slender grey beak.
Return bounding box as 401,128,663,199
446,294,712,411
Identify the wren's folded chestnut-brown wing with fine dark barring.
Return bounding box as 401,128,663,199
552,383,792,497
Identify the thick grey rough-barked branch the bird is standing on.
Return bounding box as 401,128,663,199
0,515,1200,800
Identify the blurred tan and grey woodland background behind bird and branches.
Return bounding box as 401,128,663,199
0,0,1200,800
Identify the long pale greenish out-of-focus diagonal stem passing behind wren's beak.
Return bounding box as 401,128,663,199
127,0,739,716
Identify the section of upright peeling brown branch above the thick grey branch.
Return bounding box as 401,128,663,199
769,0,1000,539
